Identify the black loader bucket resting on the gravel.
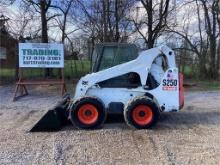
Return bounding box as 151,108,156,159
30,94,70,132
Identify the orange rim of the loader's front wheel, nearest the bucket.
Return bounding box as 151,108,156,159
78,104,98,125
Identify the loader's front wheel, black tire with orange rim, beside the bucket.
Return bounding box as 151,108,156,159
70,97,107,129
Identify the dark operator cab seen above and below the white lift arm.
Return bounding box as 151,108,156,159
92,43,141,88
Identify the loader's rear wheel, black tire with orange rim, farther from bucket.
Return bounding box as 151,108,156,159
124,96,160,129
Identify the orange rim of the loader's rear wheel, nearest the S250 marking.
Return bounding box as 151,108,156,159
132,105,153,126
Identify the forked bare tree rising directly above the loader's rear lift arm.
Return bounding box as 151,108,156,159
130,0,174,48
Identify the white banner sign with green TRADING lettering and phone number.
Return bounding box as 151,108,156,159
19,43,64,68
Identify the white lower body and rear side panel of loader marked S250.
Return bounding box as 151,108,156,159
86,68,179,111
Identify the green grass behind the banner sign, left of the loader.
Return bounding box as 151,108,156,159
0,60,90,80
